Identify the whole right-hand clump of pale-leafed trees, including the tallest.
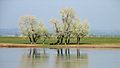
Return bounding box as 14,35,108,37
50,8,89,44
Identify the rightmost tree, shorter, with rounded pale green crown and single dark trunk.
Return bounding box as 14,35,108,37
72,19,89,44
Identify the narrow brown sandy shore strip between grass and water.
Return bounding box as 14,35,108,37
0,43,120,48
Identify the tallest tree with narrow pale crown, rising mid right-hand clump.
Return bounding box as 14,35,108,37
60,8,75,43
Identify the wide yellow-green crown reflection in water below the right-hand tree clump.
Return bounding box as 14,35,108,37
55,54,88,68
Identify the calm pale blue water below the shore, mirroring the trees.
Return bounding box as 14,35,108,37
0,48,120,68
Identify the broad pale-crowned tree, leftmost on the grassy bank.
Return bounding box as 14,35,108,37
19,16,47,43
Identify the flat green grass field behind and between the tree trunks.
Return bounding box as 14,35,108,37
0,37,120,44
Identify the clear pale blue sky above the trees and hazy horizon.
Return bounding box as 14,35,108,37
0,0,120,30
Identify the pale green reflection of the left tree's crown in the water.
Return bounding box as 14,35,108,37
21,51,48,68
